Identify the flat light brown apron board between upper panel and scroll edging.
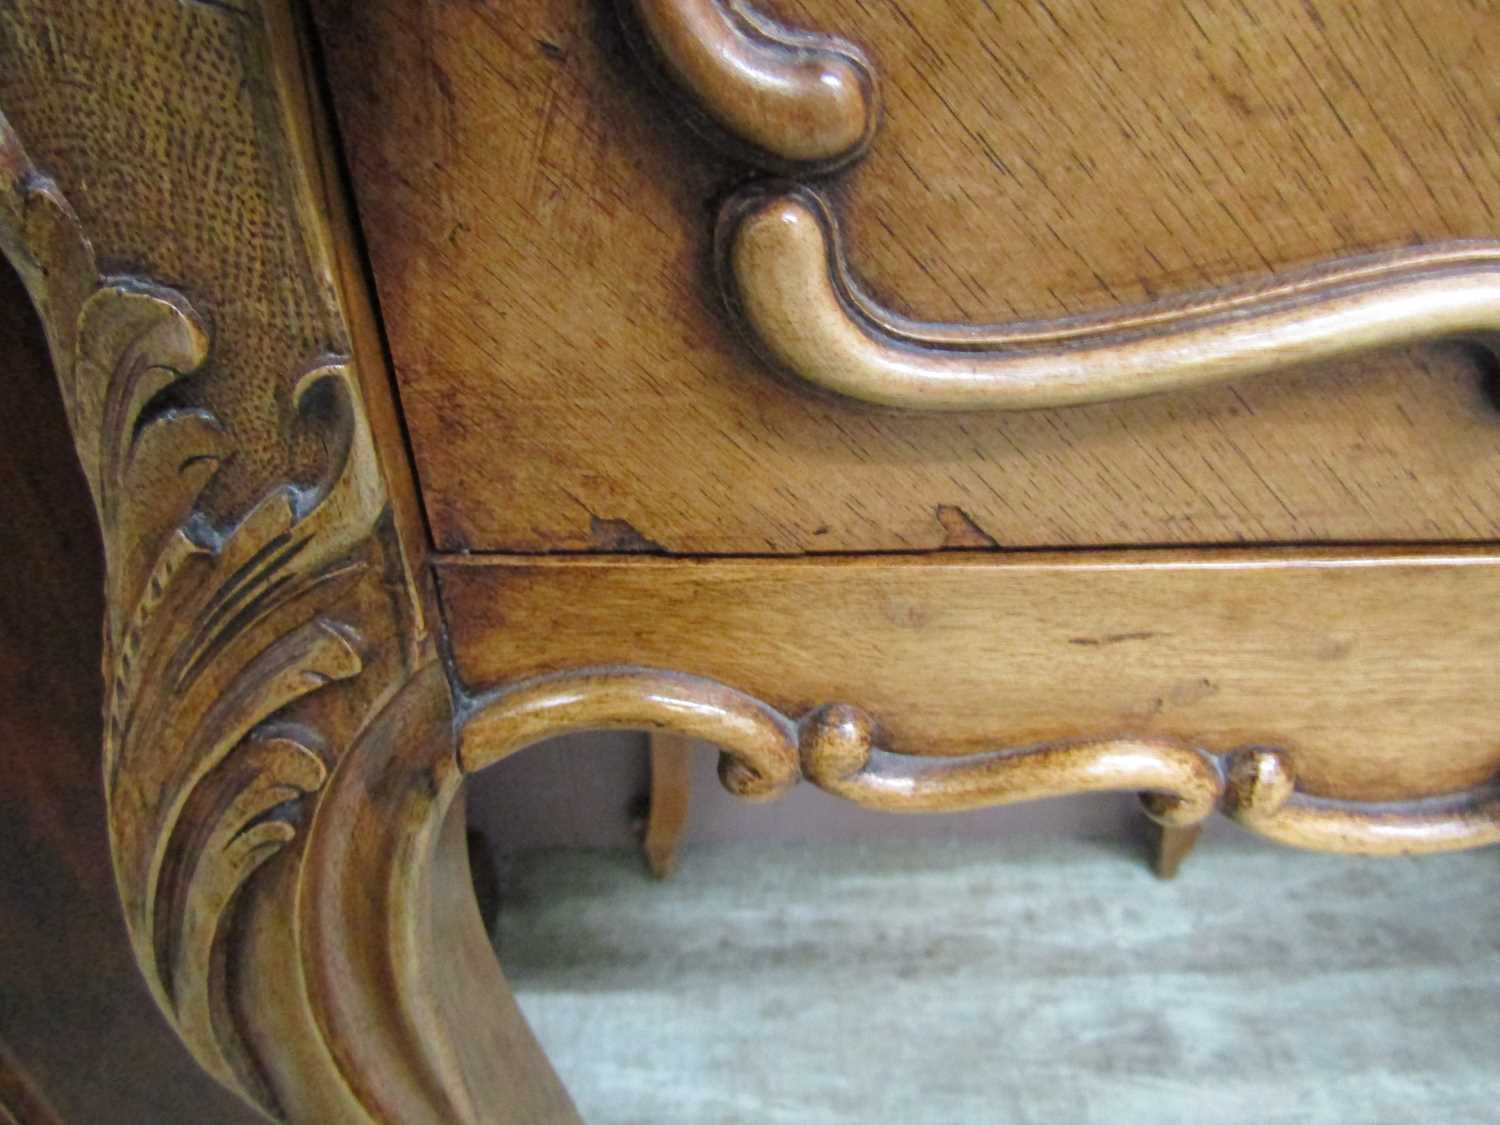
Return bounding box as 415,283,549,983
438,552,1500,801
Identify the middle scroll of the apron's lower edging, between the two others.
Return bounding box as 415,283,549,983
800,704,1224,828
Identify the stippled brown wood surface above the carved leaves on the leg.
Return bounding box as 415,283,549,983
0,0,350,518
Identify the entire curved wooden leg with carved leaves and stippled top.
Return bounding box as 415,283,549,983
0,0,575,1124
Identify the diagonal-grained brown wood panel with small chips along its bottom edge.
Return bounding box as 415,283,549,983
314,0,1500,554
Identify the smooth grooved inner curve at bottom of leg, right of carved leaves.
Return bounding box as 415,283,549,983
292,663,576,1122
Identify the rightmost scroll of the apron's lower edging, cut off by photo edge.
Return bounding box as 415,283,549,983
1224,747,1500,855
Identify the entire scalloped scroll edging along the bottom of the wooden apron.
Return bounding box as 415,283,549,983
459,668,1500,855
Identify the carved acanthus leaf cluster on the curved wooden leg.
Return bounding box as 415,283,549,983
0,110,389,1109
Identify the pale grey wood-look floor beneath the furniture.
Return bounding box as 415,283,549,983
498,834,1500,1125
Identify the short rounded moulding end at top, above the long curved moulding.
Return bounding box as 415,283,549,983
621,0,879,173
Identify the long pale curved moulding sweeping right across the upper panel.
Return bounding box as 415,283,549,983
717,183,1500,411
